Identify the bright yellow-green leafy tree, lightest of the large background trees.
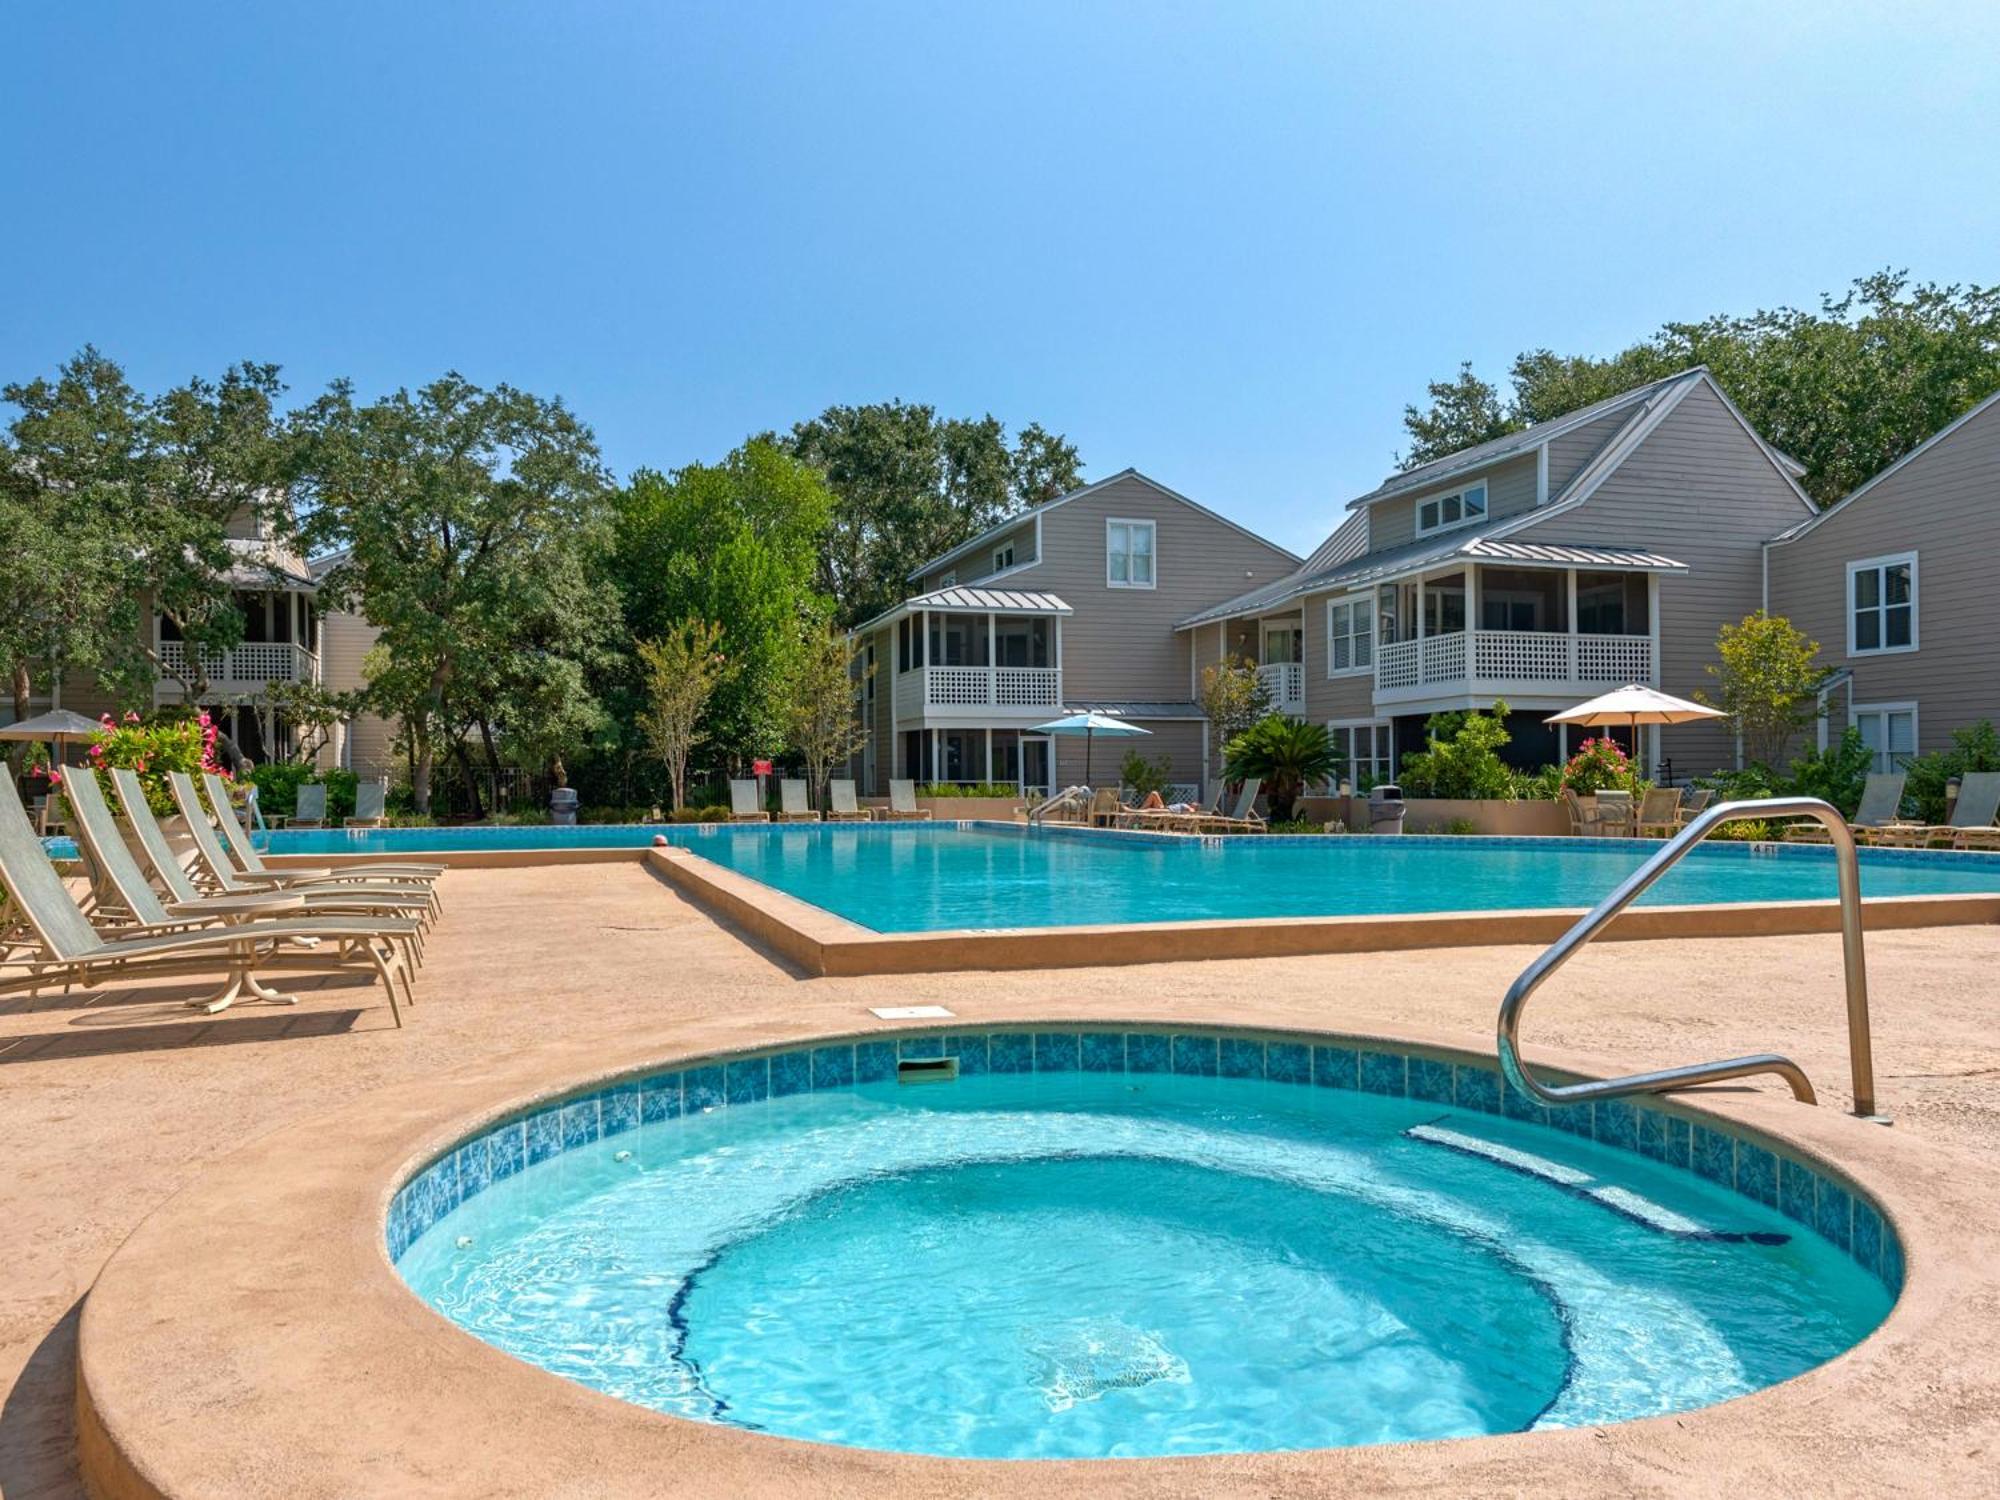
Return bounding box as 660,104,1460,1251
612,438,834,766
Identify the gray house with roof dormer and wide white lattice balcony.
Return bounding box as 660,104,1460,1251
1178,368,1814,784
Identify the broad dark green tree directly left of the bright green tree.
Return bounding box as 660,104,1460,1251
296,382,616,812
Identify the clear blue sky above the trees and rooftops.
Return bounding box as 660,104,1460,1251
0,0,2000,550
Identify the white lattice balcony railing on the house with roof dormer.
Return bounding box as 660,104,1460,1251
1376,630,1654,706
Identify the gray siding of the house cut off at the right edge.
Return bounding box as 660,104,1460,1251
1768,404,2000,752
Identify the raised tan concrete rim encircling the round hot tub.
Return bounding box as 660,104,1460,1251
78,1000,2000,1500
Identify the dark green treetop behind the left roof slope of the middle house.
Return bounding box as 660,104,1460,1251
784,402,1082,626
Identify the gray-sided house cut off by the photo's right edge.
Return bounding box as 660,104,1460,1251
1764,394,2000,770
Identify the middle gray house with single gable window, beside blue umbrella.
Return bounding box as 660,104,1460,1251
854,468,1300,796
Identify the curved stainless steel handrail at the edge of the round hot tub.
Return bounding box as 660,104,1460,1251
1500,796,1876,1116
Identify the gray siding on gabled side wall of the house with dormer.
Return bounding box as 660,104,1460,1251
1516,382,1806,772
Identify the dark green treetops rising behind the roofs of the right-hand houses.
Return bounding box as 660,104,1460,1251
1402,270,2000,506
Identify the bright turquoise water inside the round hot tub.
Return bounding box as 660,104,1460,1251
398,1072,1888,1458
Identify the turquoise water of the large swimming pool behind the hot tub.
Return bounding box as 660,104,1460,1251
272,824,2000,932
